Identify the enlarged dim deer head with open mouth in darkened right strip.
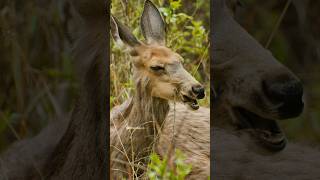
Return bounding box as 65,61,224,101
212,0,304,151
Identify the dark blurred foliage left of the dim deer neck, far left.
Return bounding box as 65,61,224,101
0,0,77,151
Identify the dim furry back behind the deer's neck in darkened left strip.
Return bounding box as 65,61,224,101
0,118,69,180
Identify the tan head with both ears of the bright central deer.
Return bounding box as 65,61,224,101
111,0,205,110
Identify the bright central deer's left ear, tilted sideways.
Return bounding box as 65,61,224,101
110,15,141,48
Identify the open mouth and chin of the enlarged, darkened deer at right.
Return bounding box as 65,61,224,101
233,107,287,151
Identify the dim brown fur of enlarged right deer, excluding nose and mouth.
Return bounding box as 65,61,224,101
211,0,320,180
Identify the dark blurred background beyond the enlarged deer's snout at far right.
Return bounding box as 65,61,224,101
229,0,320,144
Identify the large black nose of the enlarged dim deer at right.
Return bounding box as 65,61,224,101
264,80,304,119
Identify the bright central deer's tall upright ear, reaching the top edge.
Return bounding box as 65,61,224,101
140,0,165,45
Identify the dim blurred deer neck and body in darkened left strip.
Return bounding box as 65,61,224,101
0,0,110,180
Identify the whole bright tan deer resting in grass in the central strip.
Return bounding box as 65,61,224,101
110,0,210,179
